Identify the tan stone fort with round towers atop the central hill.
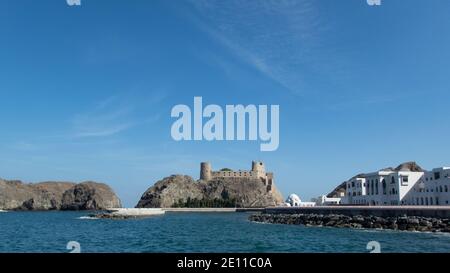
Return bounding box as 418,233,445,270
200,161,273,192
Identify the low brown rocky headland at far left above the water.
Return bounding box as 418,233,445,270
0,179,121,210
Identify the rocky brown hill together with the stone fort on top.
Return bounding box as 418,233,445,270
136,161,284,208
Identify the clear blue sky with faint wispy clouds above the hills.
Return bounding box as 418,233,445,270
0,0,450,204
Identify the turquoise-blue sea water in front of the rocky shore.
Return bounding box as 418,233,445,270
0,212,450,252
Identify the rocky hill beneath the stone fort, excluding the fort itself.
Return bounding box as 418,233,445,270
136,175,283,208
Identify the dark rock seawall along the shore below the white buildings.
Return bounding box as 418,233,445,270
249,213,450,232
